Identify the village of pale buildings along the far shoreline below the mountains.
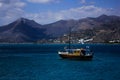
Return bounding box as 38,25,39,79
37,34,120,44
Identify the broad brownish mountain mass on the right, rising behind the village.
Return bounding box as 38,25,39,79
45,14,120,43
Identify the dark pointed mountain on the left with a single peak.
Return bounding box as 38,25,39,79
0,18,46,43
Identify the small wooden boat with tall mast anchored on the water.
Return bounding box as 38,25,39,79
58,26,93,60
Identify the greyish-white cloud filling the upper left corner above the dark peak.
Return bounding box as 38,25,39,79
0,0,26,25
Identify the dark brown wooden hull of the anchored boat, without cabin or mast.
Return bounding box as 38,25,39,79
59,54,93,60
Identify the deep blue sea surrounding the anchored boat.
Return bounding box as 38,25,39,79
0,44,120,80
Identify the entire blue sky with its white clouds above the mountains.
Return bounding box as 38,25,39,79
0,0,120,26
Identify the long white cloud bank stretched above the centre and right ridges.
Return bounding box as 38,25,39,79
25,5,117,24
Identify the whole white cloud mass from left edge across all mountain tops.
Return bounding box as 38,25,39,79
0,3,120,25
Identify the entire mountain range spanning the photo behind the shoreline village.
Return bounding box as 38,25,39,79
0,15,120,43
